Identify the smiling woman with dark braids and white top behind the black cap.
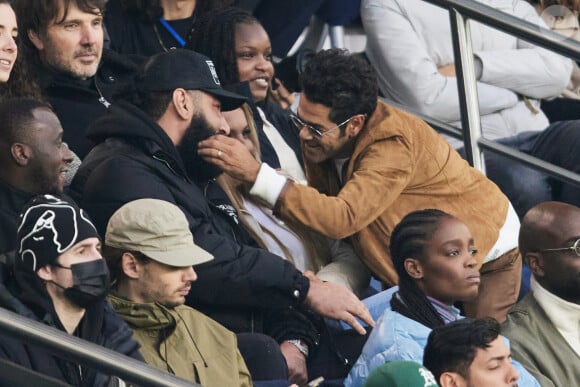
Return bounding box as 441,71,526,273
187,8,306,182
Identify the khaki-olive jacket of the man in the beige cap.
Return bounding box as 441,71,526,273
109,295,252,387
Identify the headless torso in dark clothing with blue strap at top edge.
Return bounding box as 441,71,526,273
105,0,234,56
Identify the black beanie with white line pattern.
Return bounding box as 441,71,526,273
16,195,99,272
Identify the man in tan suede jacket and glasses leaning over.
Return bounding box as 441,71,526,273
199,50,521,321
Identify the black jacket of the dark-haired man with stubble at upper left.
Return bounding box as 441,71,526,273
36,50,140,160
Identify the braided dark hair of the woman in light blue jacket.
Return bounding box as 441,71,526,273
390,209,453,328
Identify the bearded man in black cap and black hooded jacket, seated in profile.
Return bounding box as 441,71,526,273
71,49,373,384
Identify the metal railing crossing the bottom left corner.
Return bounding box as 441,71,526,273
0,308,199,387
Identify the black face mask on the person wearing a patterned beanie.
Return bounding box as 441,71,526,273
54,259,111,309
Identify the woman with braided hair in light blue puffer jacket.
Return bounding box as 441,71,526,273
345,209,539,387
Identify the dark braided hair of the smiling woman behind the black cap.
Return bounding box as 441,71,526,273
187,7,260,85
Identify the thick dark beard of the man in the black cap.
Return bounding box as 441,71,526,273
178,114,222,184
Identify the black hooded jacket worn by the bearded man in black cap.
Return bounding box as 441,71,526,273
70,102,317,343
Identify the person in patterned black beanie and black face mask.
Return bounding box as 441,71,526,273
0,195,143,386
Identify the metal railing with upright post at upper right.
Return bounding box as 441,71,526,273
416,0,580,186
